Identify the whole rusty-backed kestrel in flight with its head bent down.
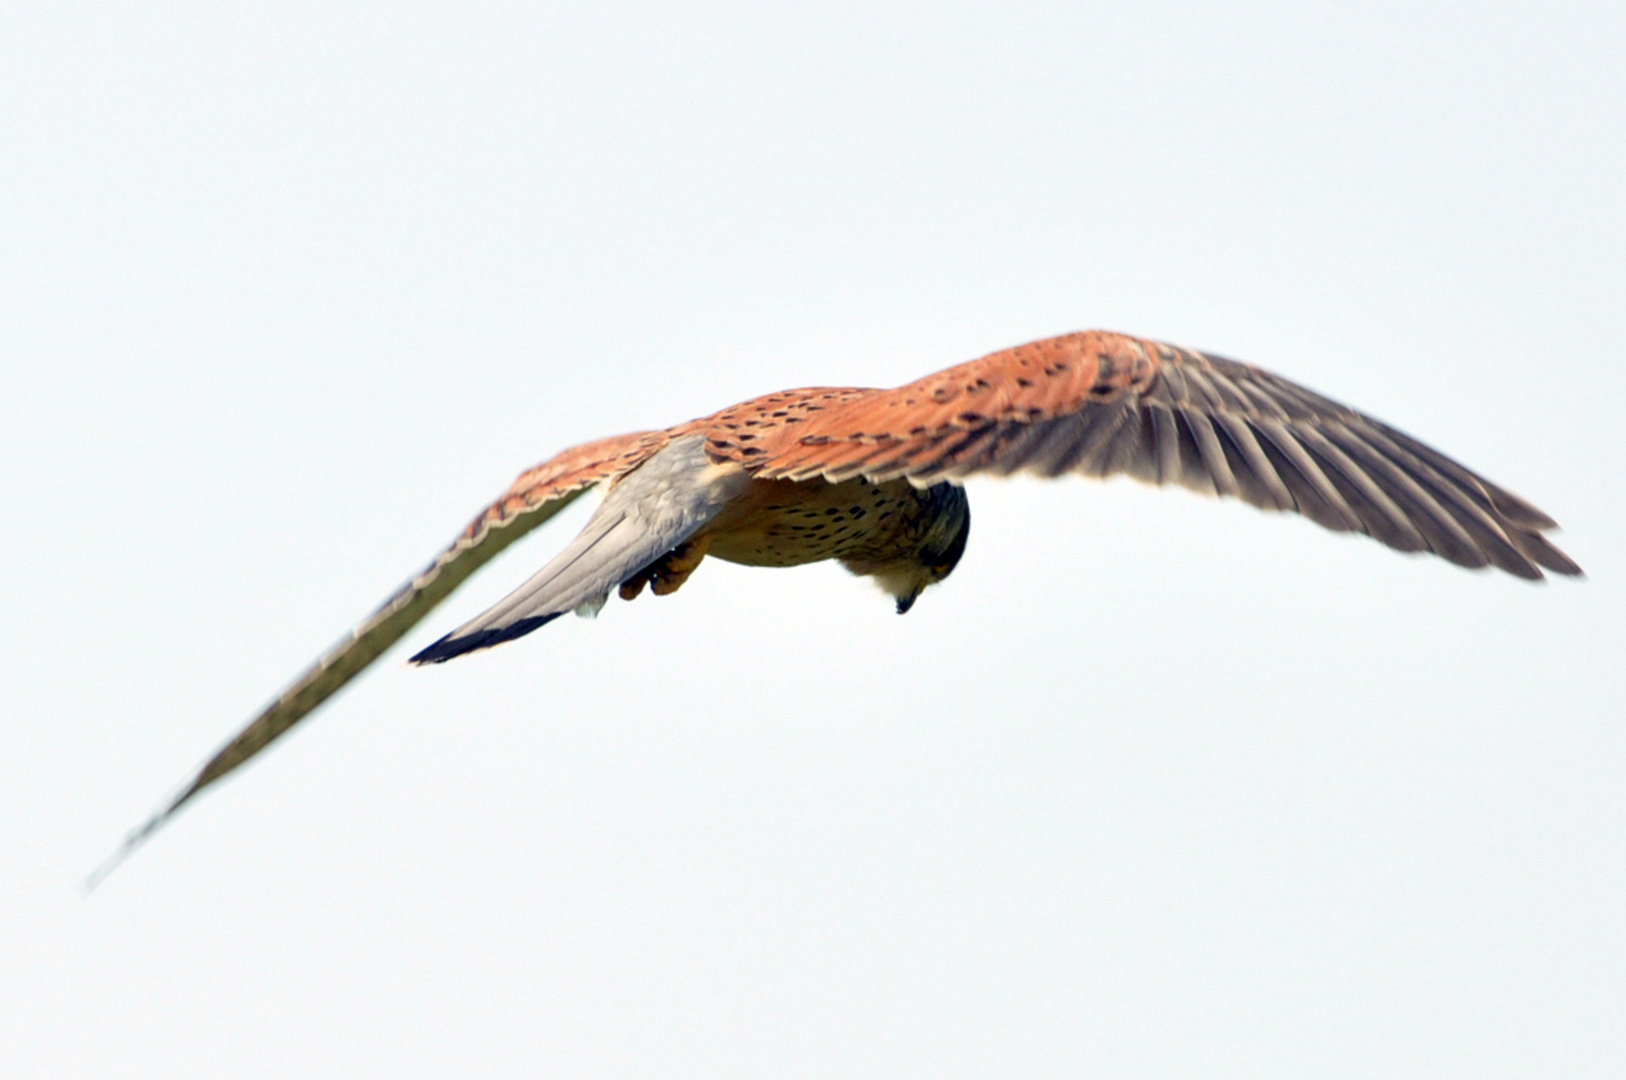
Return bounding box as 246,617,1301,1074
91,330,1582,883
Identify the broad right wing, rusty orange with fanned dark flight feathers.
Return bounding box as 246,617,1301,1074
711,330,1580,579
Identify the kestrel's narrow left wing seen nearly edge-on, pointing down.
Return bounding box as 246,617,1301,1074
89,431,667,885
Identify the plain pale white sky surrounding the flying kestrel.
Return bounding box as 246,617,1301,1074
0,0,1626,1080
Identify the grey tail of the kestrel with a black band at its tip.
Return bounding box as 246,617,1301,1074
411,434,751,664
